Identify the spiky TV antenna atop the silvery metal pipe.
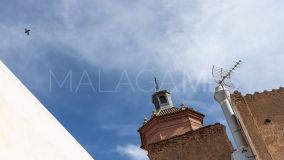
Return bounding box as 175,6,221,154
212,60,242,87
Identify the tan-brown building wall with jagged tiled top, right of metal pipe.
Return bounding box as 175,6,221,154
231,88,284,160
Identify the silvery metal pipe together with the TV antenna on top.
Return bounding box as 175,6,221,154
212,60,255,160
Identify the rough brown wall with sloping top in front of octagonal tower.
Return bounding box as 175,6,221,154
146,124,233,160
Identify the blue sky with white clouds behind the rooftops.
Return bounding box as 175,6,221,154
0,0,284,160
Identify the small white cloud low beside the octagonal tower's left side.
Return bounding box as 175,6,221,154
116,144,148,160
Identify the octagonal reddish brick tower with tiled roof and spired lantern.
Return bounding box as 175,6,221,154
138,78,204,149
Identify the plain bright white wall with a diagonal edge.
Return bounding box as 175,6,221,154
0,62,93,160
